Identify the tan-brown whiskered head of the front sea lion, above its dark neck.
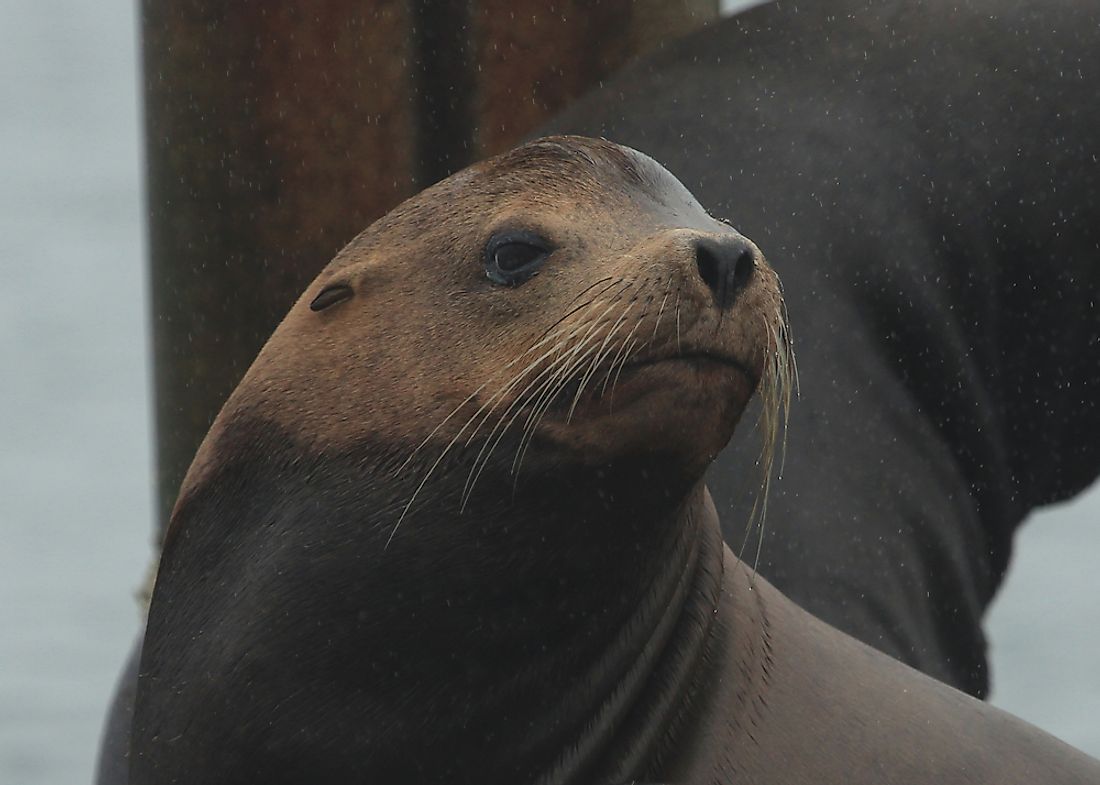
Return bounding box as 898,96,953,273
182,136,785,525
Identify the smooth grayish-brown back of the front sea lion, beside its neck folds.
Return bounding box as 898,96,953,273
663,499,1100,785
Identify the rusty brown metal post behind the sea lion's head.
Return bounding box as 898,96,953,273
142,0,717,527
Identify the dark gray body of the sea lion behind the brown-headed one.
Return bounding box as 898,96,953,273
548,0,1100,697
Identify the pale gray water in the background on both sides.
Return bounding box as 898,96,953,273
0,0,1100,785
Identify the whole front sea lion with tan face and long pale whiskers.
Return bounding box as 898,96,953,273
131,137,1100,785
